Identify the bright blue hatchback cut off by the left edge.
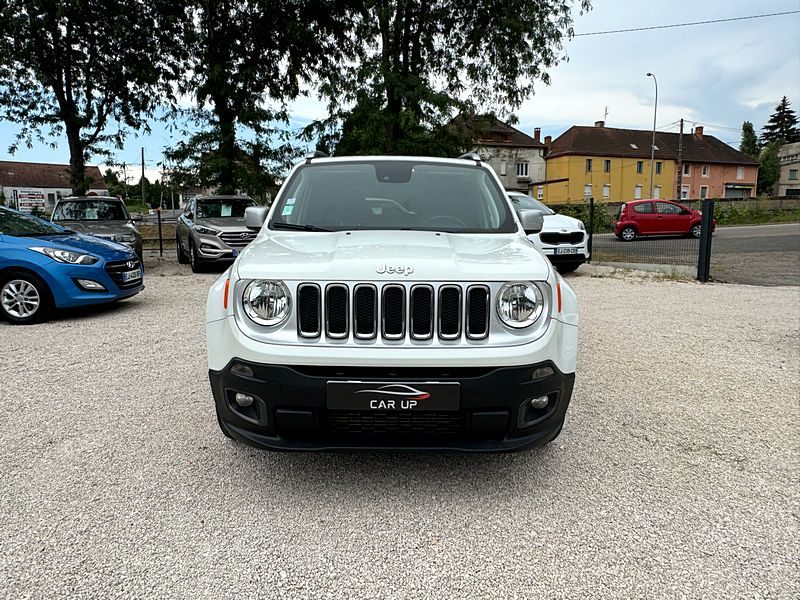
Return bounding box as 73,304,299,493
0,207,144,324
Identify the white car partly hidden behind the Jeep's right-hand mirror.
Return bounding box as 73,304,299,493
508,192,589,273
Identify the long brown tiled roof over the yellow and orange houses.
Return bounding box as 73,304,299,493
547,125,760,165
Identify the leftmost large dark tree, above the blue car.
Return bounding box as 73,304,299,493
0,0,185,194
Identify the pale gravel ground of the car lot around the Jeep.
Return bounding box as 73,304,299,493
0,266,800,598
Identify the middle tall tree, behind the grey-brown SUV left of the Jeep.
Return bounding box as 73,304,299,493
166,0,348,193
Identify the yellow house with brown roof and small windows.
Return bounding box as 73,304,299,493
531,121,677,204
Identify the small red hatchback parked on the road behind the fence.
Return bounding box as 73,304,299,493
614,200,717,242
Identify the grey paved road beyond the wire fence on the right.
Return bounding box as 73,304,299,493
594,223,800,285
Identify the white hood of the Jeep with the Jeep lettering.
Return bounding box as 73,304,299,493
237,229,550,281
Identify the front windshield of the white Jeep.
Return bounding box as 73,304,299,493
269,160,516,233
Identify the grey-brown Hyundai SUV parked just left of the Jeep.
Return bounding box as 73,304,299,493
175,196,257,273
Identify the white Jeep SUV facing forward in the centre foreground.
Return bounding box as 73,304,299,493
206,154,578,451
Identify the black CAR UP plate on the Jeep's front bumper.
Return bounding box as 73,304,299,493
328,381,461,411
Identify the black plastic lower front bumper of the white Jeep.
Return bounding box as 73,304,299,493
209,358,575,451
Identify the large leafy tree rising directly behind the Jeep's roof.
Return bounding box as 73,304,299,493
305,0,590,154
